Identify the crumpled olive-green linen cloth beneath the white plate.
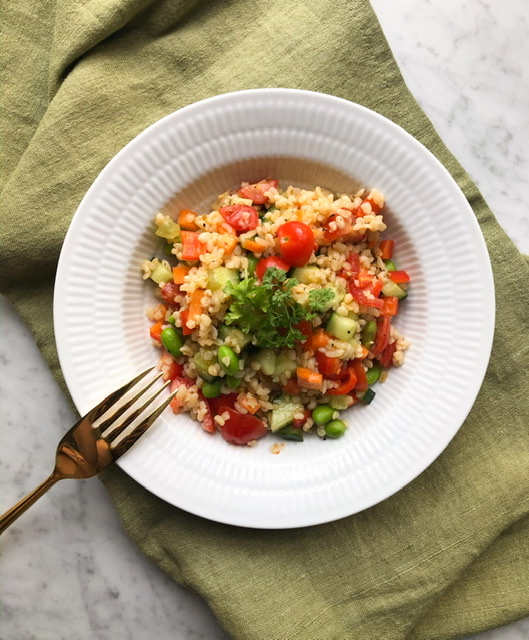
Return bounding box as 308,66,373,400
1,0,529,640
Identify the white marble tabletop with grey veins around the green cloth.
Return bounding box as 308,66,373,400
0,0,529,640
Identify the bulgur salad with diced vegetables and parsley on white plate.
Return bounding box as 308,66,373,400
142,179,409,446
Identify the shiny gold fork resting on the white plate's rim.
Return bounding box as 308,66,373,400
0,367,177,534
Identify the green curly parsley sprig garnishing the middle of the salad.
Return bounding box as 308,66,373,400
224,268,334,348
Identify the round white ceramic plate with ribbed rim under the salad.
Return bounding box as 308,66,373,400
54,89,494,528
